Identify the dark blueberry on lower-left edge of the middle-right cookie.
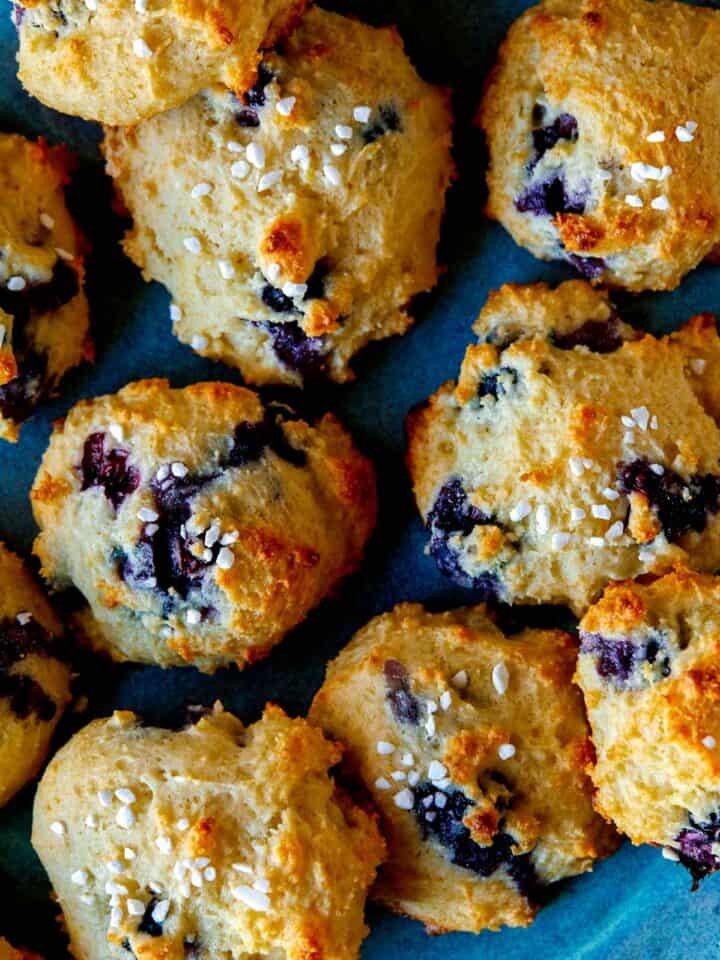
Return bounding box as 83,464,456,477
427,477,501,600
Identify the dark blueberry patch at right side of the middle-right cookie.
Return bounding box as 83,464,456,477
618,460,720,543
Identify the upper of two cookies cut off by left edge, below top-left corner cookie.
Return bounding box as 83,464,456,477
0,134,90,441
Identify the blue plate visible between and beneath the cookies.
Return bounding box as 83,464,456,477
0,0,720,960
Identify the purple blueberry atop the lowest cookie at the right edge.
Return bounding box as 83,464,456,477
580,629,672,687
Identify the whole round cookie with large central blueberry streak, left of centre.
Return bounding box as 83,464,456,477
32,380,376,671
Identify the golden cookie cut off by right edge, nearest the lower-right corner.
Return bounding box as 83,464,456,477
577,569,720,883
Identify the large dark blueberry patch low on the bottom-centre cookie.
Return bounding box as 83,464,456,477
413,783,540,901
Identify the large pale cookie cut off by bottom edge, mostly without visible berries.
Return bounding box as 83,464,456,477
32,706,384,960
